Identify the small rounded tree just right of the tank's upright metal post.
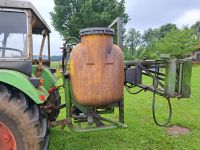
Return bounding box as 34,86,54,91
125,28,142,56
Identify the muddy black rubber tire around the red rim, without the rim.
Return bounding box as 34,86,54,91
0,84,48,150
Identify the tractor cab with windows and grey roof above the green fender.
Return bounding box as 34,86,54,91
0,0,51,76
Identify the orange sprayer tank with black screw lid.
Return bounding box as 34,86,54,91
70,28,124,106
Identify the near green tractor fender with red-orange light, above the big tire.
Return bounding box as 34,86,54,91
0,69,49,104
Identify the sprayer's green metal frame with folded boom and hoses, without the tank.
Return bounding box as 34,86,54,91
51,17,192,132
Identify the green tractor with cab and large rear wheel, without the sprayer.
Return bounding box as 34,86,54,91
0,1,58,150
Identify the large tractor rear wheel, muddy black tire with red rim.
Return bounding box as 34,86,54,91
0,85,49,150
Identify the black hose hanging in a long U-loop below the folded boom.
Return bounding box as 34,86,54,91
152,92,172,127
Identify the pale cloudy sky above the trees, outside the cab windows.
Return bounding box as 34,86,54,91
27,0,200,55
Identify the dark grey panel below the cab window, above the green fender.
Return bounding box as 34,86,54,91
0,60,32,77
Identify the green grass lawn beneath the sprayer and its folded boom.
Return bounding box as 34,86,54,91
49,66,200,150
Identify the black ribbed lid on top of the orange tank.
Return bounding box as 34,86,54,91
80,27,114,36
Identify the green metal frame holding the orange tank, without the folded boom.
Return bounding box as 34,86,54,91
51,18,127,132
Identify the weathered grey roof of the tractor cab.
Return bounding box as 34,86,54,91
0,0,51,32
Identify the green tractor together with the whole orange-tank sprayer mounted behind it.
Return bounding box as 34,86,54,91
0,0,192,150
